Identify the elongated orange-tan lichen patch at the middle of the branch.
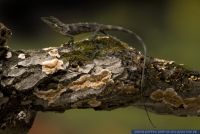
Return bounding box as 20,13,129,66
69,69,113,91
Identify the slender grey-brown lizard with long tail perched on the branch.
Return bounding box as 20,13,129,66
41,16,155,128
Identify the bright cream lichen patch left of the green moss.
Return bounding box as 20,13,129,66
41,58,64,74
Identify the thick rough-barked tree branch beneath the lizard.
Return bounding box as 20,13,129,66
0,23,200,134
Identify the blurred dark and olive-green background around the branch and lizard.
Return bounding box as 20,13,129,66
0,0,200,134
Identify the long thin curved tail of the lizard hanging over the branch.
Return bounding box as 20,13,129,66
108,26,156,128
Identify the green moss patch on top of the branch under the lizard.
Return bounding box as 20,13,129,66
61,36,128,61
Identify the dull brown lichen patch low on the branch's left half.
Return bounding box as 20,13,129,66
33,86,66,105
